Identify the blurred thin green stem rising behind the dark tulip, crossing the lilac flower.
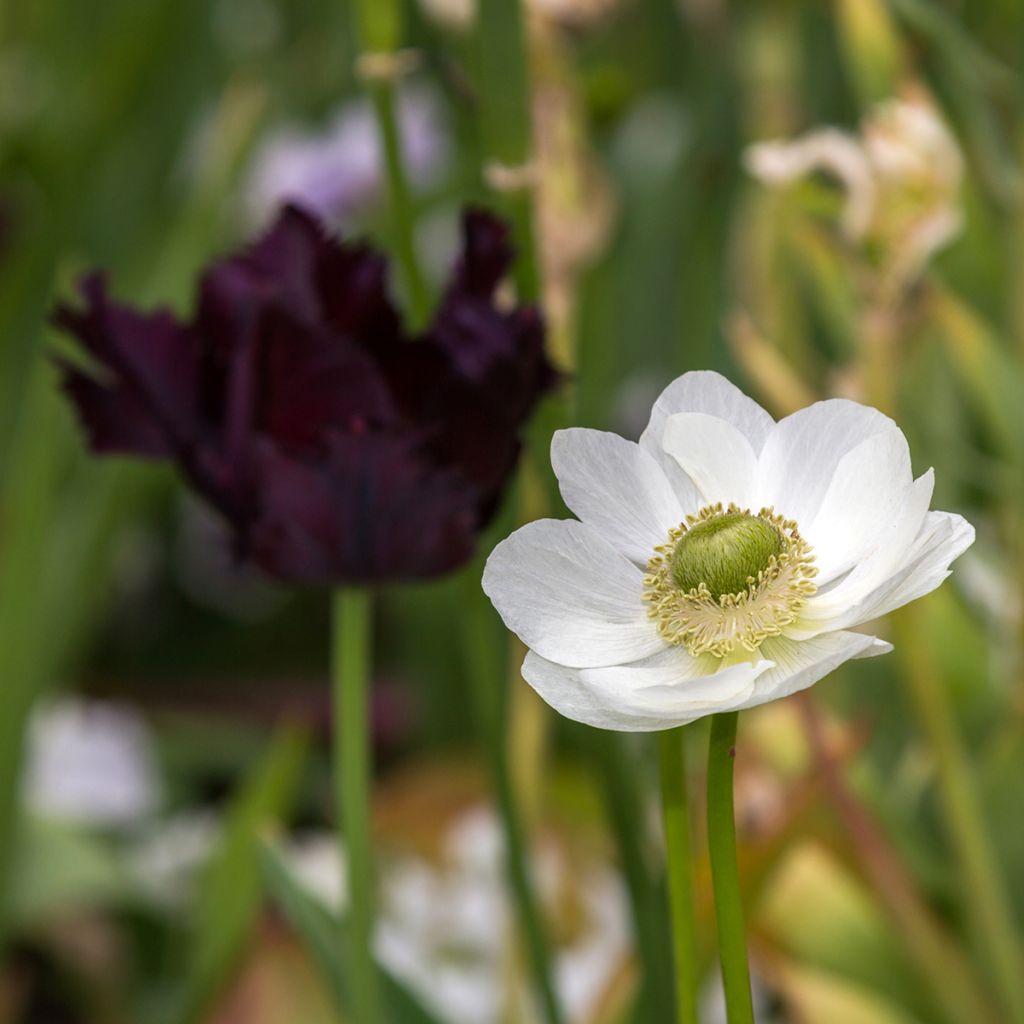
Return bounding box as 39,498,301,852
355,0,430,327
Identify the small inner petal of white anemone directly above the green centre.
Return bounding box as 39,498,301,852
662,413,758,511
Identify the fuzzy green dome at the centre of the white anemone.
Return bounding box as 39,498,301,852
672,512,784,599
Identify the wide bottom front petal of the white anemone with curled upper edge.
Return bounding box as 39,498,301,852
522,647,771,732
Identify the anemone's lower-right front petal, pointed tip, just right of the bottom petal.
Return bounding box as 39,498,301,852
741,633,892,708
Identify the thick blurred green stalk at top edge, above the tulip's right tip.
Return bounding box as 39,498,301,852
477,0,541,302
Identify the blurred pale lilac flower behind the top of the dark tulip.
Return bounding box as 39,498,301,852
245,88,450,225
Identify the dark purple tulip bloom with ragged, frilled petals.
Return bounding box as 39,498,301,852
54,207,557,584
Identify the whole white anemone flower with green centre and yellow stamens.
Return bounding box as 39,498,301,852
483,373,974,732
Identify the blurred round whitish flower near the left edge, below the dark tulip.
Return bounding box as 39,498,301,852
24,697,161,825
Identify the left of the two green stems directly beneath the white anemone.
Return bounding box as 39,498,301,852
657,728,698,1024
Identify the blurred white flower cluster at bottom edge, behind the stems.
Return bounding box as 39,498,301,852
286,807,630,1024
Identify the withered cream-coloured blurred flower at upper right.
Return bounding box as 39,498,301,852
745,94,964,288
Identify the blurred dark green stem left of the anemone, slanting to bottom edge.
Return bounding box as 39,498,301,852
463,577,563,1024
